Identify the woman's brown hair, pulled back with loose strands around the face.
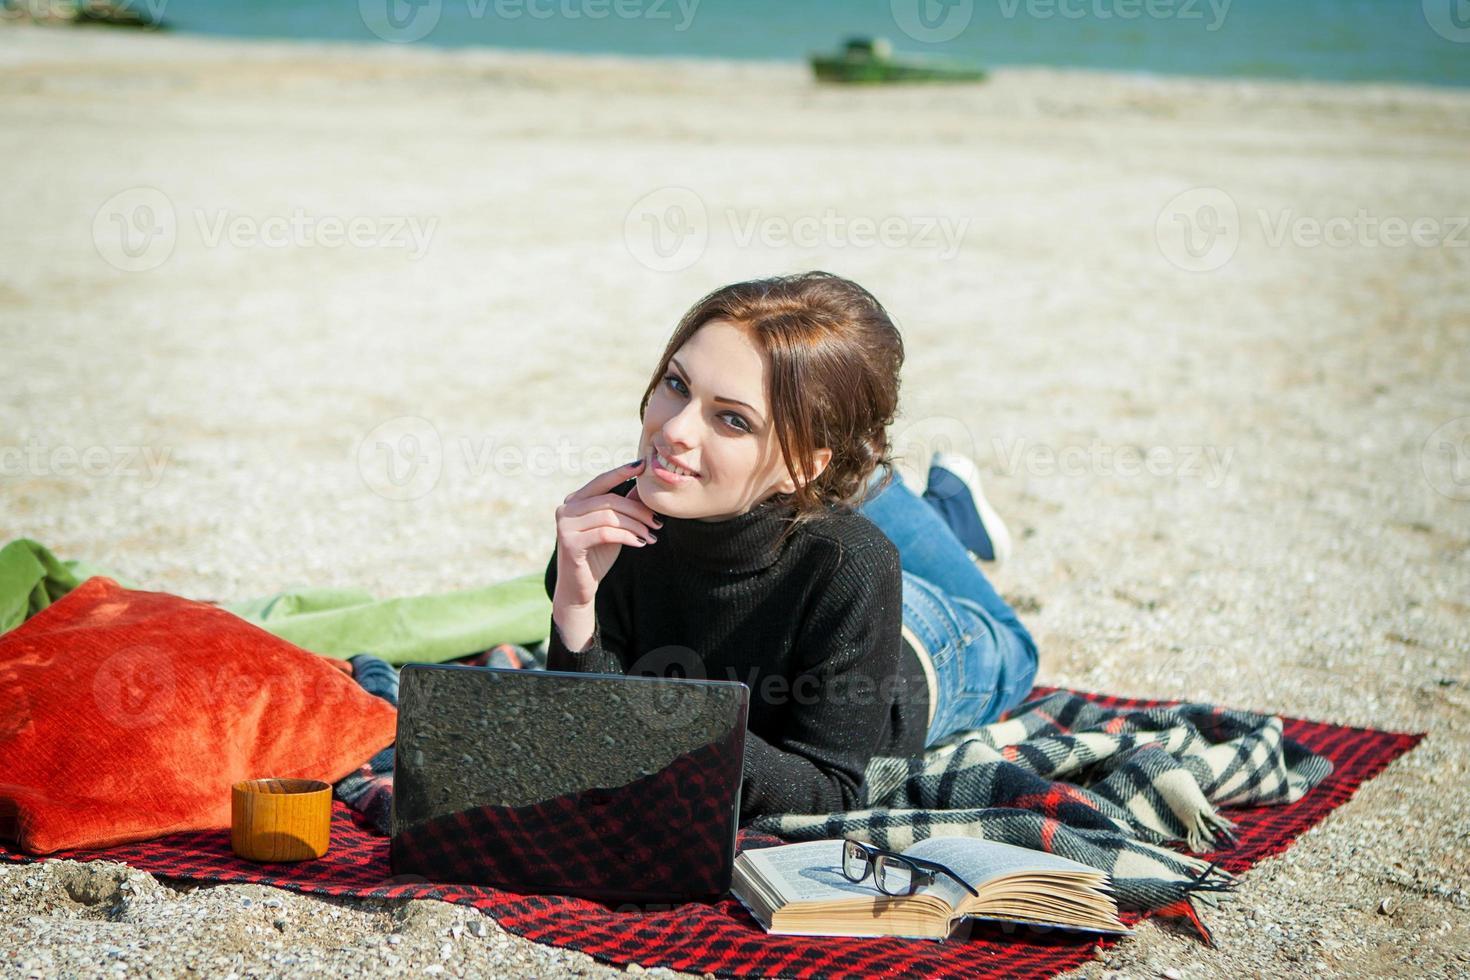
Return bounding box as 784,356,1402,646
638,272,904,543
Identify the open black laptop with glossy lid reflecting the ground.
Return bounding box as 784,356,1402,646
390,664,750,902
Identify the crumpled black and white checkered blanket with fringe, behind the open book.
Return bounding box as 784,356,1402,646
747,691,1332,909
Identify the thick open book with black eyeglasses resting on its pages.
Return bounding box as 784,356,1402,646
731,837,1129,939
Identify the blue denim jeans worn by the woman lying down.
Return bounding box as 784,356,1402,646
858,470,1036,745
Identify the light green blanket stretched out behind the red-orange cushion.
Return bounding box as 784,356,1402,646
0,538,551,664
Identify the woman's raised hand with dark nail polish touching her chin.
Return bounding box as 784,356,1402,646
553,460,662,607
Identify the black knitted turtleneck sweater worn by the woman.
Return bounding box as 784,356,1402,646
545,480,929,823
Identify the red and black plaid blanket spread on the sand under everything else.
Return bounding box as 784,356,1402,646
0,695,1423,979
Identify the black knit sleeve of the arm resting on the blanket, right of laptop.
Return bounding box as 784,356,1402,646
741,538,903,821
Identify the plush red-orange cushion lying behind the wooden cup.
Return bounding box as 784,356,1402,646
0,576,397,854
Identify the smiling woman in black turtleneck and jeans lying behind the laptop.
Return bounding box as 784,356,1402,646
545,272,1036,823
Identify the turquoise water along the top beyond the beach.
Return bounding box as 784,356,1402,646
152,0,1470,85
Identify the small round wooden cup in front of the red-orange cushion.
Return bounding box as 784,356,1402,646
229,779,332,861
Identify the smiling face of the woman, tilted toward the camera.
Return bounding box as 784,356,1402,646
638,320,832,520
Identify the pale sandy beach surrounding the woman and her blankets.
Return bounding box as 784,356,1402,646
0,25,1470,979
